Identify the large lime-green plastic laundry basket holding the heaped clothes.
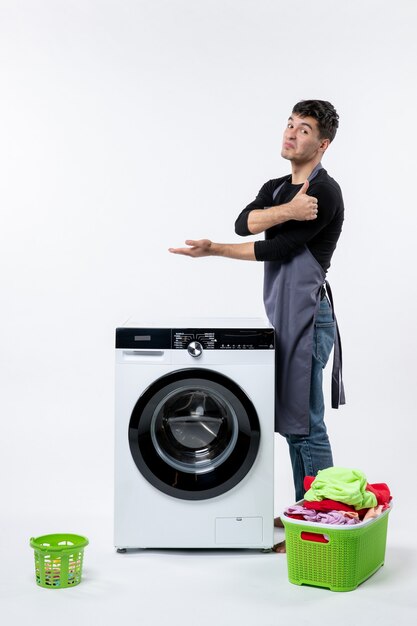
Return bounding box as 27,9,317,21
281,507,391,591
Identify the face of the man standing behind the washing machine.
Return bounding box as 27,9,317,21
281,113,330,164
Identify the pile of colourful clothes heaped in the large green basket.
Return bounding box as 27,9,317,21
284,467,392,525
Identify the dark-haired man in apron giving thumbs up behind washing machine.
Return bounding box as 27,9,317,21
170,100,344,548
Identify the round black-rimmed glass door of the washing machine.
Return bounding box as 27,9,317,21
129,369,260,500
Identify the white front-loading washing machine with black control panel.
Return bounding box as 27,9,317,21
115,319,275,551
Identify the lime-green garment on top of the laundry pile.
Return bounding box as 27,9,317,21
304,467,378,511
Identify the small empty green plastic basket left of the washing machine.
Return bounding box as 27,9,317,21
30,534,88,589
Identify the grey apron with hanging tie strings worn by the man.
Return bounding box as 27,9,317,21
264,164,345,435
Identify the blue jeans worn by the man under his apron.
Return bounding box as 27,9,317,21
286,297,335,502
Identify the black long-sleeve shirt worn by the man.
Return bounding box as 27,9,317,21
235,168,344,272
